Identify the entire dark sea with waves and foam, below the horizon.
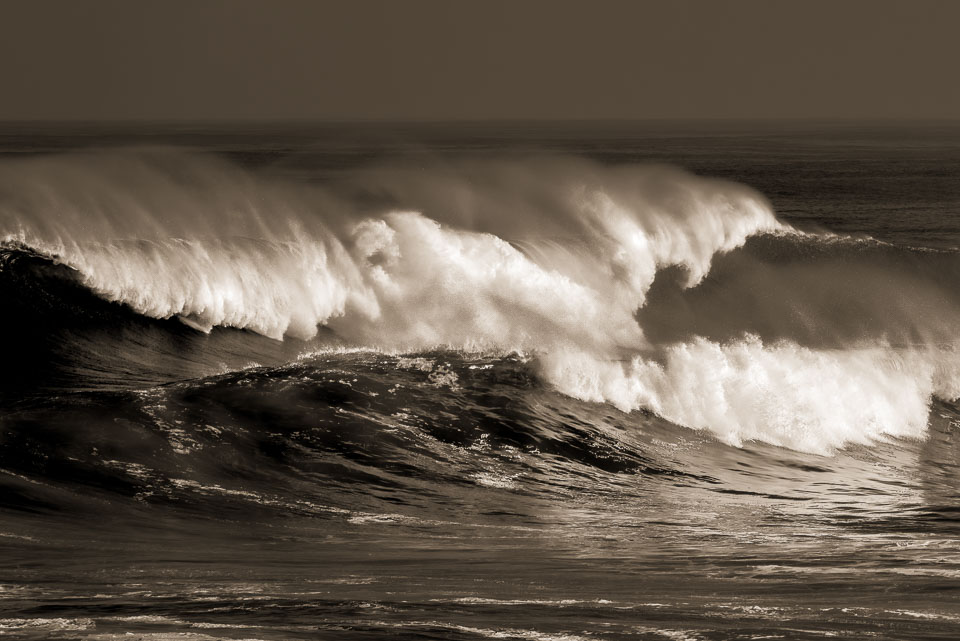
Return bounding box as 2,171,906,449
0,122,960,641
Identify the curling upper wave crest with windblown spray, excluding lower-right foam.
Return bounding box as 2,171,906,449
0,152,784,347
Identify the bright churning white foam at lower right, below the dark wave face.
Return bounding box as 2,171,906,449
544,336,960,454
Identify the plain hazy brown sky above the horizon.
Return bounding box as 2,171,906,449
0,0,960,120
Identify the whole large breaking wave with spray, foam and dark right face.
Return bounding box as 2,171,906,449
0,150,960,453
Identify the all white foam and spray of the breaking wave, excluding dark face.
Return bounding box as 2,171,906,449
7,153,960,453
